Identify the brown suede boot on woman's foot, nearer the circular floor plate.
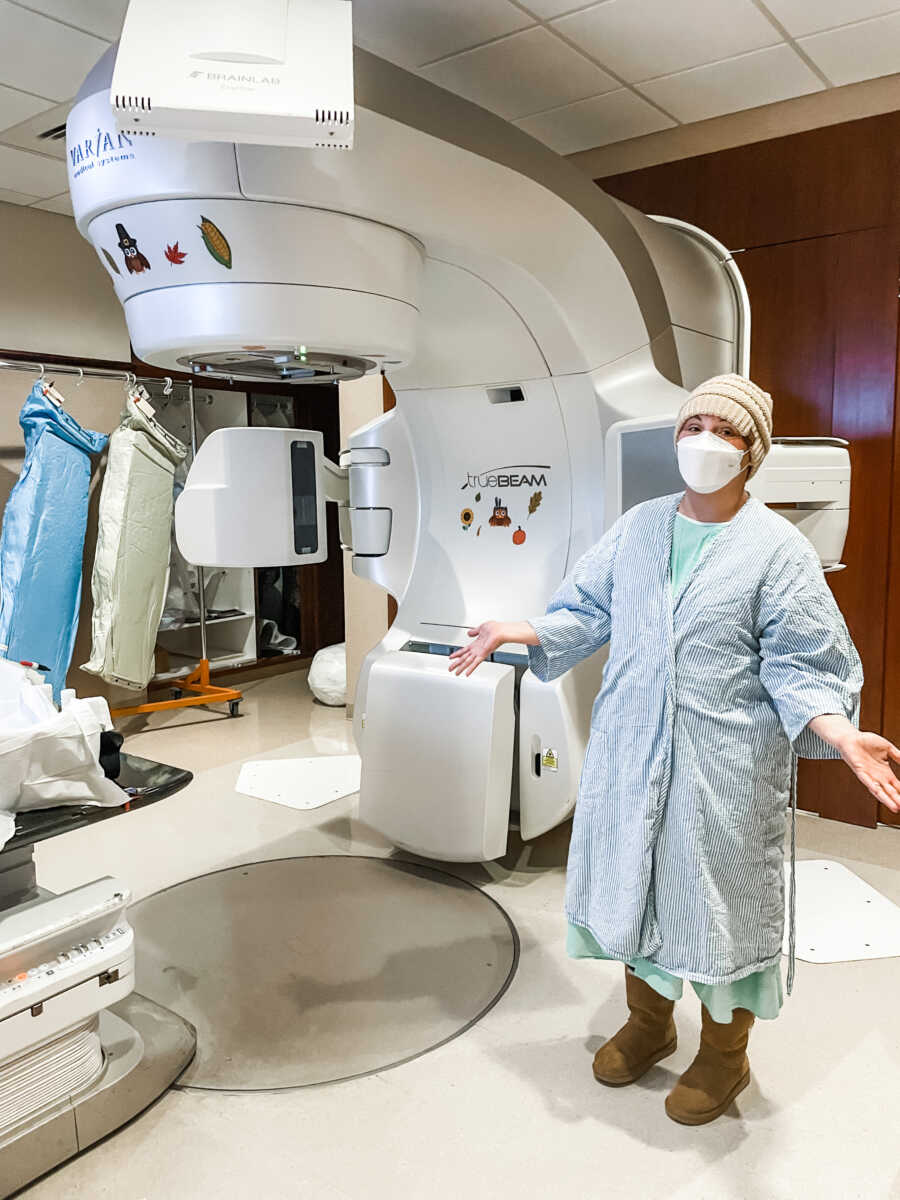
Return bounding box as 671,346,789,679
594,967,678,1087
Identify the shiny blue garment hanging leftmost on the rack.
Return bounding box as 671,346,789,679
0,383,107,700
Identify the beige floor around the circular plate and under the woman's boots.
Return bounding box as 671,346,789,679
23,673,900,1200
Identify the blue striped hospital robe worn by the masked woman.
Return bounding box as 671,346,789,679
529,496,863,984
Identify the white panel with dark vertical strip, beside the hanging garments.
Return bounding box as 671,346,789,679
175,428,328,566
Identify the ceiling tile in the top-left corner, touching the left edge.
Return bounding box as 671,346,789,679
0,0,107,101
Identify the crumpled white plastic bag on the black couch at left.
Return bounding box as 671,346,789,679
0,660,127,847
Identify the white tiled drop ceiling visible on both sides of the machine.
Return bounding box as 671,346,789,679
0,0,900,199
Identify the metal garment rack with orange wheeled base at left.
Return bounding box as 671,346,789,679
0,359,244,719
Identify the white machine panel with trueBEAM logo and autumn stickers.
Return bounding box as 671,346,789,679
391,379,571,642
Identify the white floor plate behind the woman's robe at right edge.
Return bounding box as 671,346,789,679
784,859,900,962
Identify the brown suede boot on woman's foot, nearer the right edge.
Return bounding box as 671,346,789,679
666,1008,754,1124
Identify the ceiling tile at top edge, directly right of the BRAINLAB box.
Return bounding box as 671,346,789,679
353,0,534,67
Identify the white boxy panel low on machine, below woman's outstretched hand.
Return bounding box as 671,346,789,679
360,650,515,863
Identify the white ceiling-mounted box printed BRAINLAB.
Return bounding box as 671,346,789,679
109,0,354,150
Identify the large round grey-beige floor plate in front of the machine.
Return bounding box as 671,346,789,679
131,854,518,1091
